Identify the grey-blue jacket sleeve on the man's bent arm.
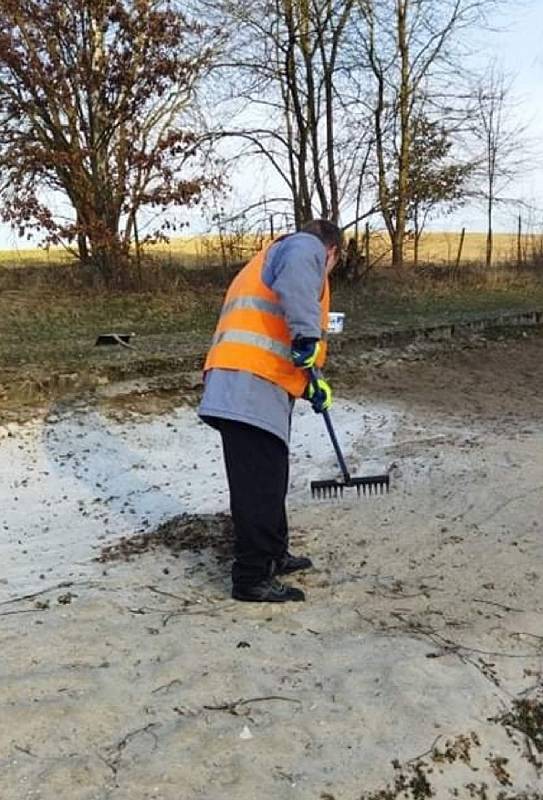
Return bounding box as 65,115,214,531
262,233,326,339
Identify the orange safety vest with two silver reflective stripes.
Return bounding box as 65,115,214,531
204,248,330,397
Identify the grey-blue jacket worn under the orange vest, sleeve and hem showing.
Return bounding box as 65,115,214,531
198,233,326,446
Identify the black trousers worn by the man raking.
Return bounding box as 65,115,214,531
216,419,288,586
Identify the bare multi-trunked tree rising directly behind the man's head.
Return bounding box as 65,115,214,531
198,0,368,227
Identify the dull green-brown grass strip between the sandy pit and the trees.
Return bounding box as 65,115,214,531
0,244,543,416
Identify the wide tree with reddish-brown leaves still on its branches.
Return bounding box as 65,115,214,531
0,0,217,281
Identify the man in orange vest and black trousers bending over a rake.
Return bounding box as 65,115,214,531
198,220,341,602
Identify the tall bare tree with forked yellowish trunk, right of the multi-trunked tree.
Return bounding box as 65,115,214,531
360,0,504,266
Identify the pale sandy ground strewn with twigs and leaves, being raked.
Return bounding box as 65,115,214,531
0,337,543,800
